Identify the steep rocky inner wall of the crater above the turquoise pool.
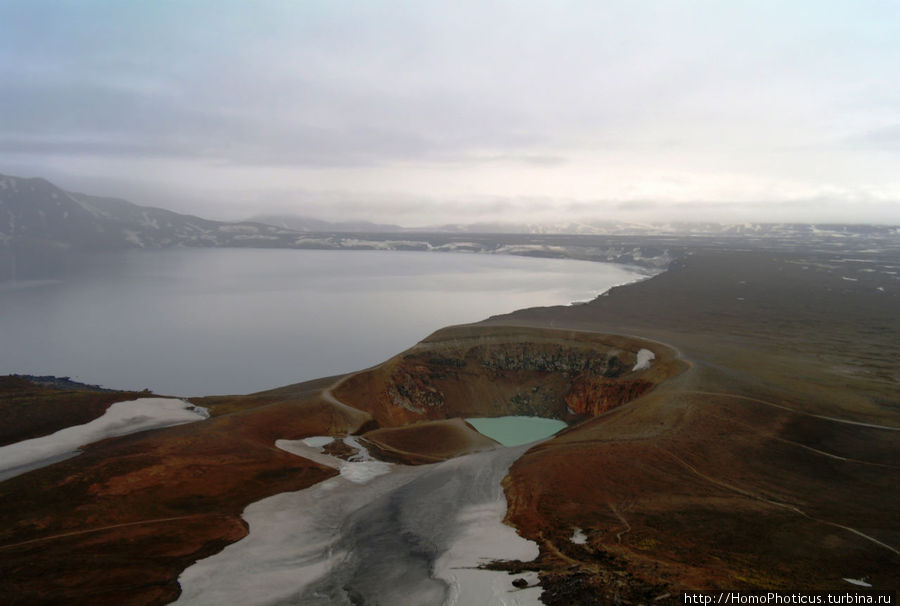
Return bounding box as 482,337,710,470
335,327,674,427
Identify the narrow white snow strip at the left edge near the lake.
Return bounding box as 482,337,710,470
0,398,209,481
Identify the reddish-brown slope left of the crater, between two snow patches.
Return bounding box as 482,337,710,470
0,380,370,605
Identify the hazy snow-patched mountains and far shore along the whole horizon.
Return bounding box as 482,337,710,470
0,175,900,262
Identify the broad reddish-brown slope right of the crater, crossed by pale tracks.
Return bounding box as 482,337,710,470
488,253,900,604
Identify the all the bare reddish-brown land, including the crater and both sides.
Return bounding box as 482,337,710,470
0,253,900,604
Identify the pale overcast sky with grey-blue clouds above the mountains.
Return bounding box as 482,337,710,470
0,0,900,226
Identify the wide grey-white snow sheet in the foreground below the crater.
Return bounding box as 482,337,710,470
176,439,540,606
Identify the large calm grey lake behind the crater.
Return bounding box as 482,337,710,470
0,249,644,396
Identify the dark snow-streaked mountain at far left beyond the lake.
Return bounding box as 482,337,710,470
0,175,297,250
